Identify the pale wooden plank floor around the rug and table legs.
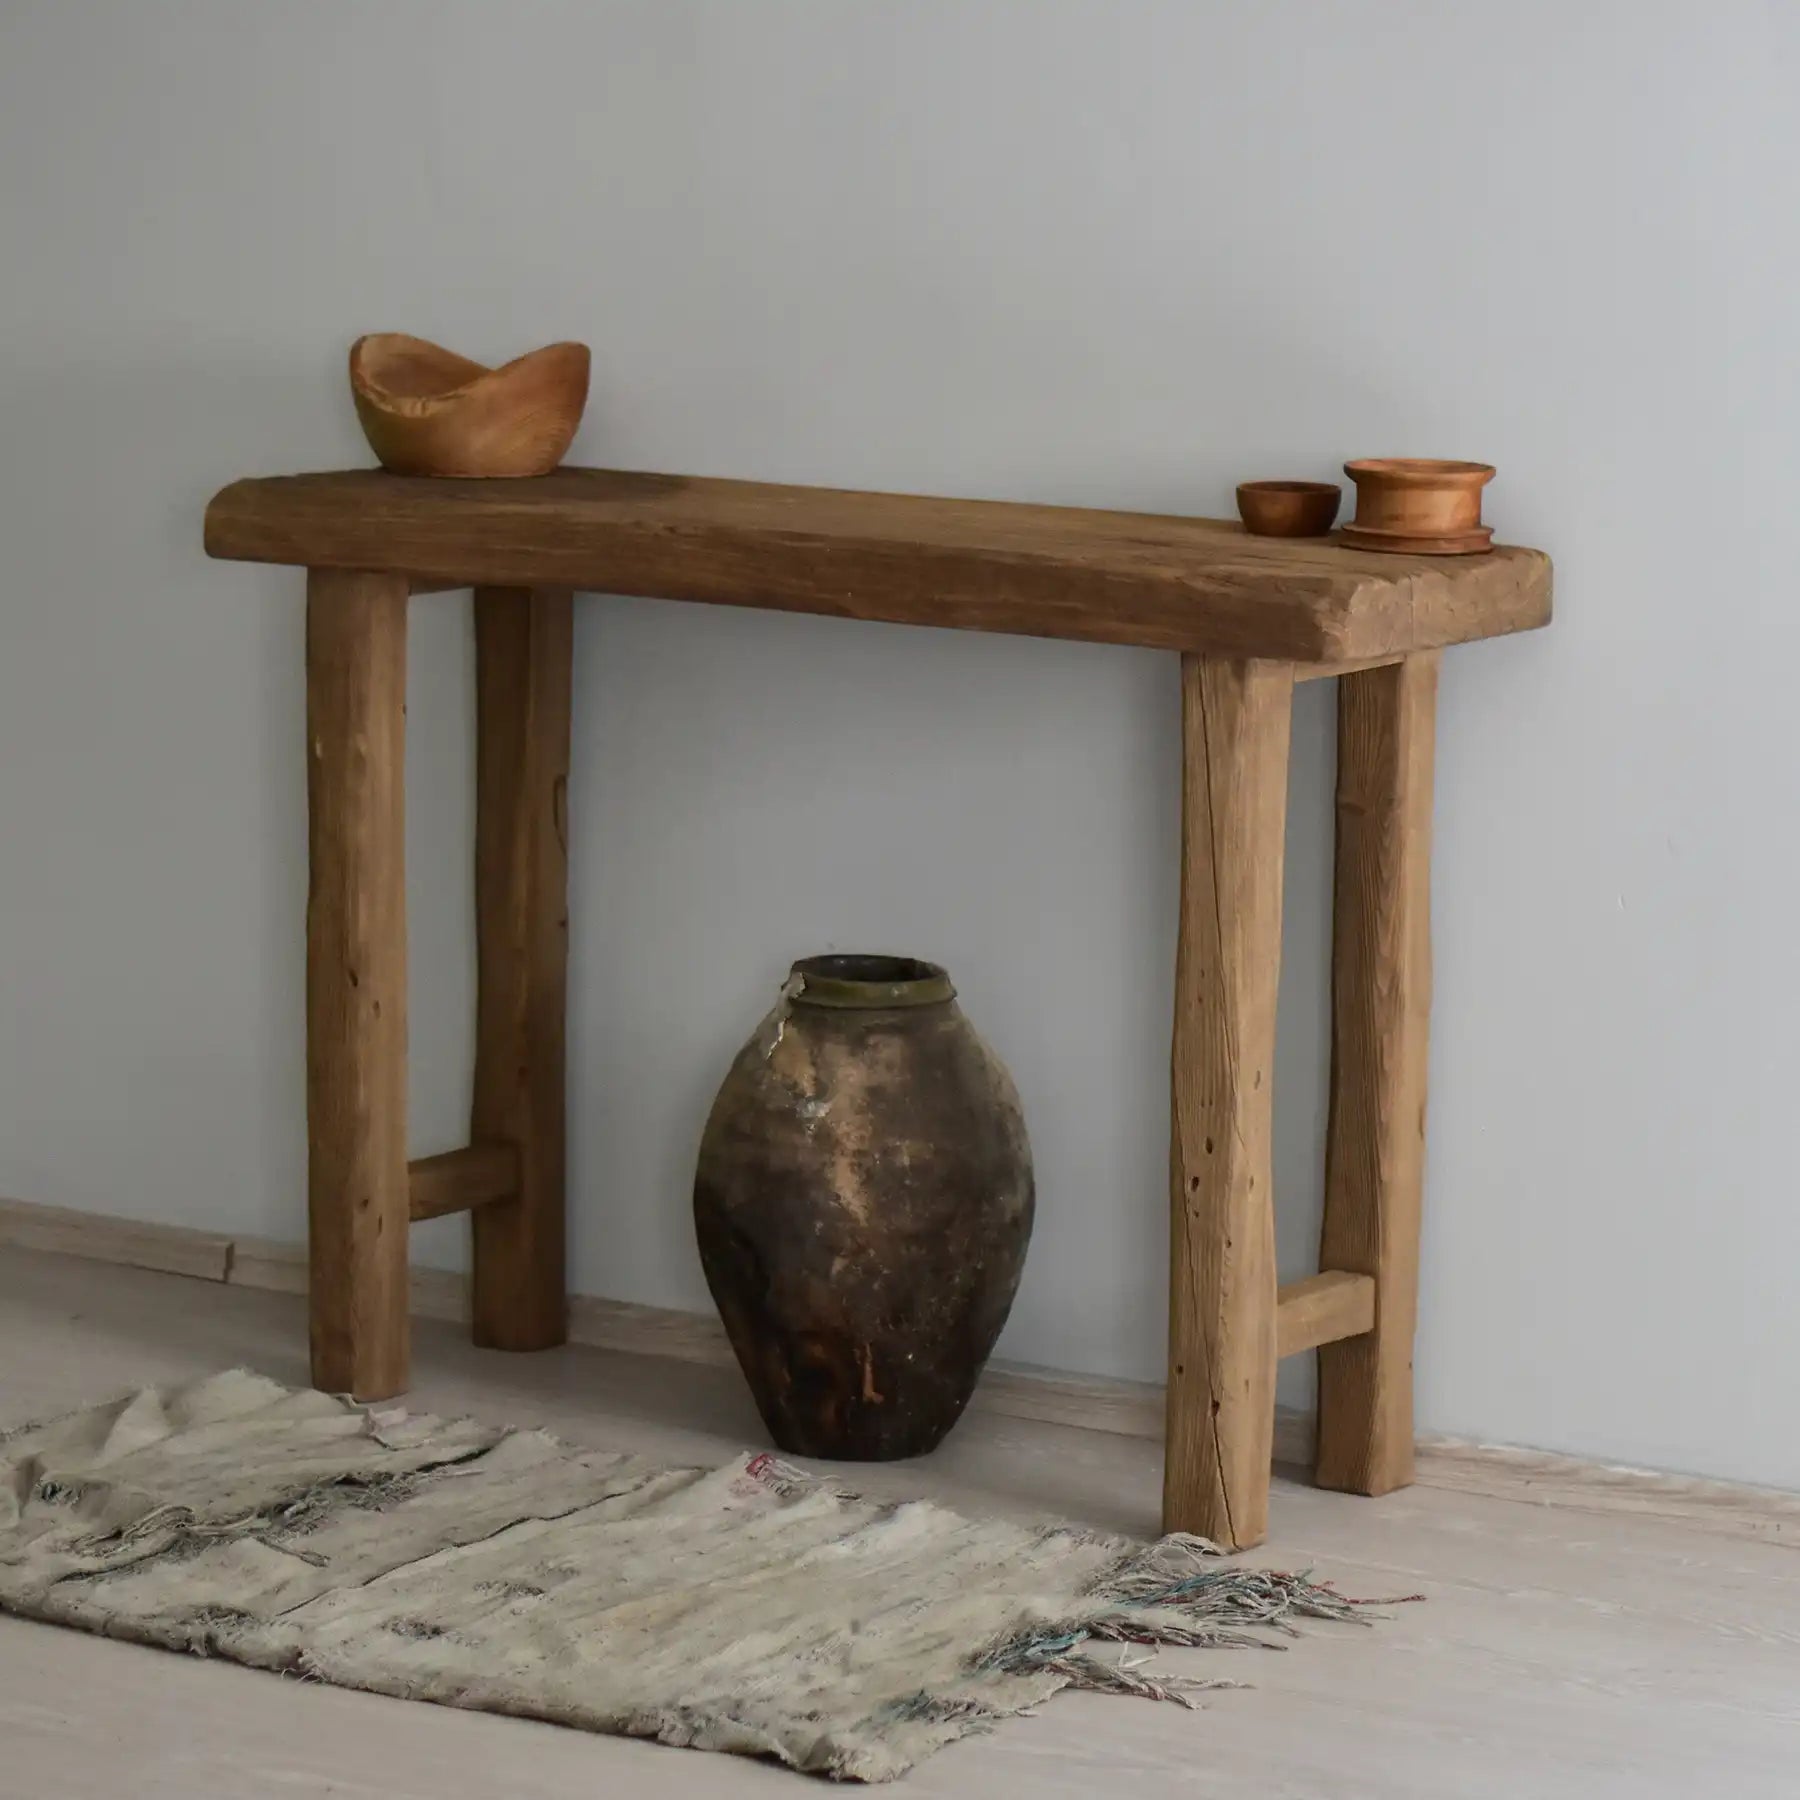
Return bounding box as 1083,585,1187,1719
0,1249,1800,1800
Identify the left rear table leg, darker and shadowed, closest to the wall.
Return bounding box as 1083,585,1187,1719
470,587,574,1350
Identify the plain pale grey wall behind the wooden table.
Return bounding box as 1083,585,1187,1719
0,0,1800,1485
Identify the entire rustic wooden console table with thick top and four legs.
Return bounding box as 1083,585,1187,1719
205,470,1550,1548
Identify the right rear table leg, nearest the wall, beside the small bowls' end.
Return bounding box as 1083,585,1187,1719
1316,653,1438,1494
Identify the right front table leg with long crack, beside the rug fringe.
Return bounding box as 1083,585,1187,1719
1163,657,1294,1550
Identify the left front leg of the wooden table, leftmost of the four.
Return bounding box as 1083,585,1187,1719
306,569,407,1400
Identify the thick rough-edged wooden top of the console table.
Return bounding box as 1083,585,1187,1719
205,468,1550,662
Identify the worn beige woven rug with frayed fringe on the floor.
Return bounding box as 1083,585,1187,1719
0,1370,1357,1782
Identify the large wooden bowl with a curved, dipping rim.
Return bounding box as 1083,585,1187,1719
349,331,589,477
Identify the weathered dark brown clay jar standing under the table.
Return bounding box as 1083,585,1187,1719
693,956,1033,1462
